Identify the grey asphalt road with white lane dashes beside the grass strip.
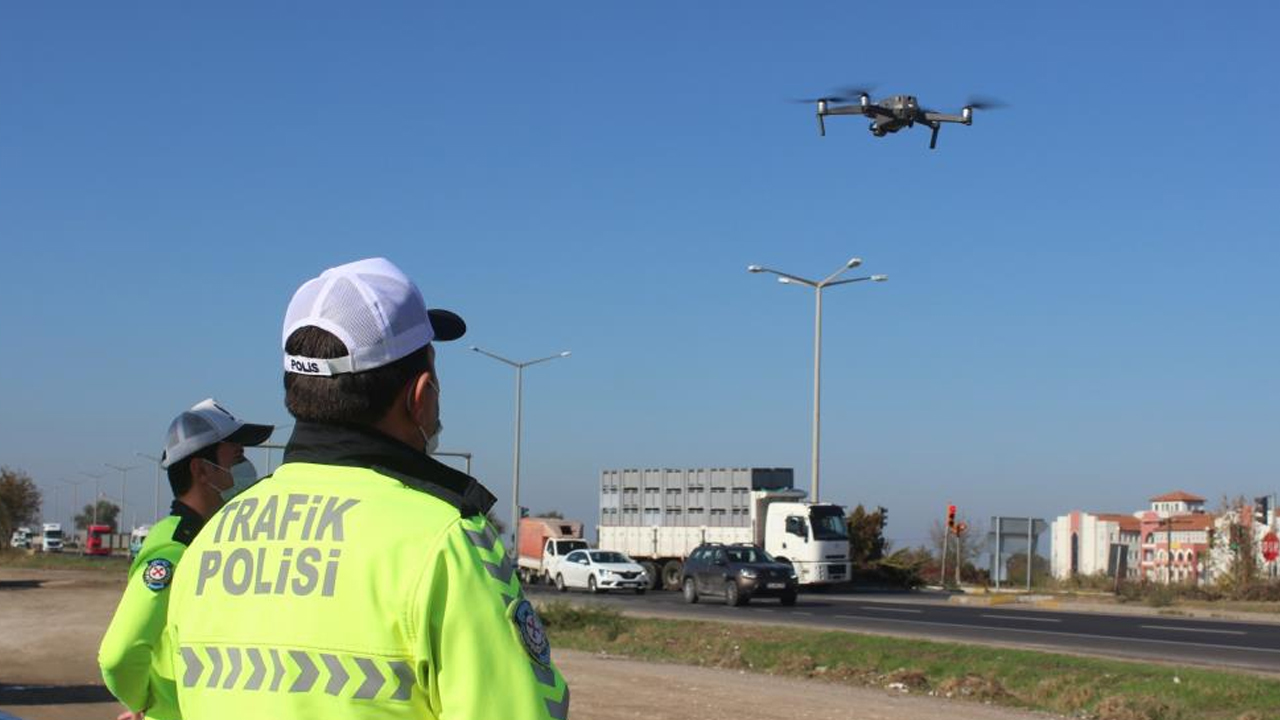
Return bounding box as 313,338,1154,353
529,587,1280,674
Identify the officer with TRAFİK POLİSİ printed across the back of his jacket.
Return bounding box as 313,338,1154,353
168,258,570,720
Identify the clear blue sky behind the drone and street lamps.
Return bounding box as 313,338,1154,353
0,3,1280,542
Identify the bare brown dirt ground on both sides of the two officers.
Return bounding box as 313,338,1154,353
0,568,1044,720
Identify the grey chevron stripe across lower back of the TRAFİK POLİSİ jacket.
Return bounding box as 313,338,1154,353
179,646,417,702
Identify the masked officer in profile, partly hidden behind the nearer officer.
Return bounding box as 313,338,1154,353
97,398,275,720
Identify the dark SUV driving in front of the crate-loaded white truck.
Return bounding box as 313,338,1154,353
680,543,797,605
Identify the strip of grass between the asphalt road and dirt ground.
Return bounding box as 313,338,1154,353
540,602,1280,720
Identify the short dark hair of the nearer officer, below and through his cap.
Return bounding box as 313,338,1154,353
284,325,433,425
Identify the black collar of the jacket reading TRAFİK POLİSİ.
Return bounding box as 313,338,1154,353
284,421,498,516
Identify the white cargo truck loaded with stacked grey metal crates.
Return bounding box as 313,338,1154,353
599,468,850,589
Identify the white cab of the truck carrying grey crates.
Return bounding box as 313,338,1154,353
763,502,850,584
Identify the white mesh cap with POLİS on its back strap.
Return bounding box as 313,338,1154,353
282,258,467,375
